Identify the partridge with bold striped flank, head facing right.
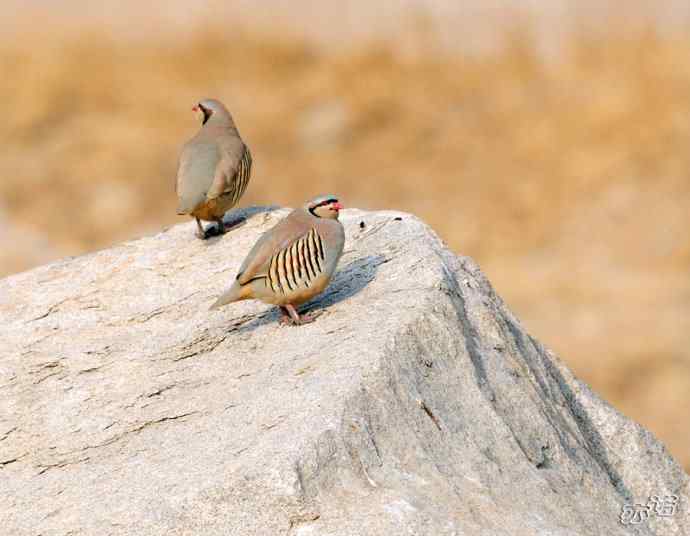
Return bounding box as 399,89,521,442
211,195,345,324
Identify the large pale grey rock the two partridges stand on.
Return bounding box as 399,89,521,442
0,210,690,536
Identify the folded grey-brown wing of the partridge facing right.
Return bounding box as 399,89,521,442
237,209,313,285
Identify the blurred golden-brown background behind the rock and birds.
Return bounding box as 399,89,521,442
0,0,690,470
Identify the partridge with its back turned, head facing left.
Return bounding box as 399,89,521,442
175,99,252,239
